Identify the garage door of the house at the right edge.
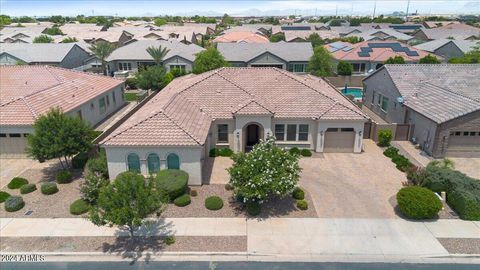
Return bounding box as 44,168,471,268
446,131,480,157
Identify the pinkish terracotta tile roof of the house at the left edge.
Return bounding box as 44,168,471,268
0,66,123,125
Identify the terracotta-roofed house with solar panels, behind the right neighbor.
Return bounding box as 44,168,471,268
325,41,428,74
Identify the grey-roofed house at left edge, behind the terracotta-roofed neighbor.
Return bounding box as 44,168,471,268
0,43,90,69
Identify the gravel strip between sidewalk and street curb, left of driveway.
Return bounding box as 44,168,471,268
0,236,247,255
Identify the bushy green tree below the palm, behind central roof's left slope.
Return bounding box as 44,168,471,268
136,66,173,91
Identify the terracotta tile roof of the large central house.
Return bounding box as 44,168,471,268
101,68,367,146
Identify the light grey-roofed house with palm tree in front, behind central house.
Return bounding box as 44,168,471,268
107,40,204,74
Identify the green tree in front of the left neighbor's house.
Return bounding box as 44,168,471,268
27,108,95,169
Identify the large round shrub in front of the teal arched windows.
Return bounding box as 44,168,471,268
156,169,188,201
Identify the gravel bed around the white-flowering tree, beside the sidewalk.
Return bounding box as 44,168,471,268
162,185,317,218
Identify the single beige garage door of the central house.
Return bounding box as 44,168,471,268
323,128,355,153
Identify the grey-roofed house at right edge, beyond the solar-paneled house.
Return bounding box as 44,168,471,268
413,39,480,60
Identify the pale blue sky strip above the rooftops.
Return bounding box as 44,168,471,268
0,0,480,16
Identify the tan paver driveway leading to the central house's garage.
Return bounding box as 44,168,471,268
300,140,407,218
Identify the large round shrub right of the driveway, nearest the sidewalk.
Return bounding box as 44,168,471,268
397,186,442,219
